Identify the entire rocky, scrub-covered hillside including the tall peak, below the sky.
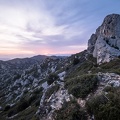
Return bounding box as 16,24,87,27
0,14,120,120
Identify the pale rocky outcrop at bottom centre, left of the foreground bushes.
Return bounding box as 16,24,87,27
37,82,73,120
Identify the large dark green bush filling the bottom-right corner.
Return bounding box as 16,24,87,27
86,91,120,120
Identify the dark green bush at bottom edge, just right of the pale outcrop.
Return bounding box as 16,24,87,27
54,101,87,120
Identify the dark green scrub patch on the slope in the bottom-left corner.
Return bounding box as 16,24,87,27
0,87,43,120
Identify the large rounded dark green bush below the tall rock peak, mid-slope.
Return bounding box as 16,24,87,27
65,74,98,98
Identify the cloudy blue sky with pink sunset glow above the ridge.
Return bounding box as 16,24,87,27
0,0,120,60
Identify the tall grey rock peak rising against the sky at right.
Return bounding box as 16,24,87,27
87,14,120,64
